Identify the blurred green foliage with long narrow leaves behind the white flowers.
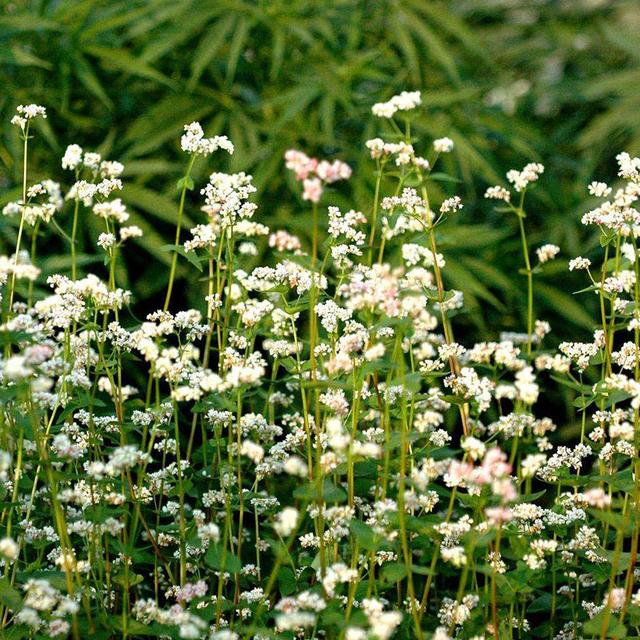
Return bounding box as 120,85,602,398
0,0,640,336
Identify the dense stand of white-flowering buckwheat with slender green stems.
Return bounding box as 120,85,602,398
0,92,640,640
